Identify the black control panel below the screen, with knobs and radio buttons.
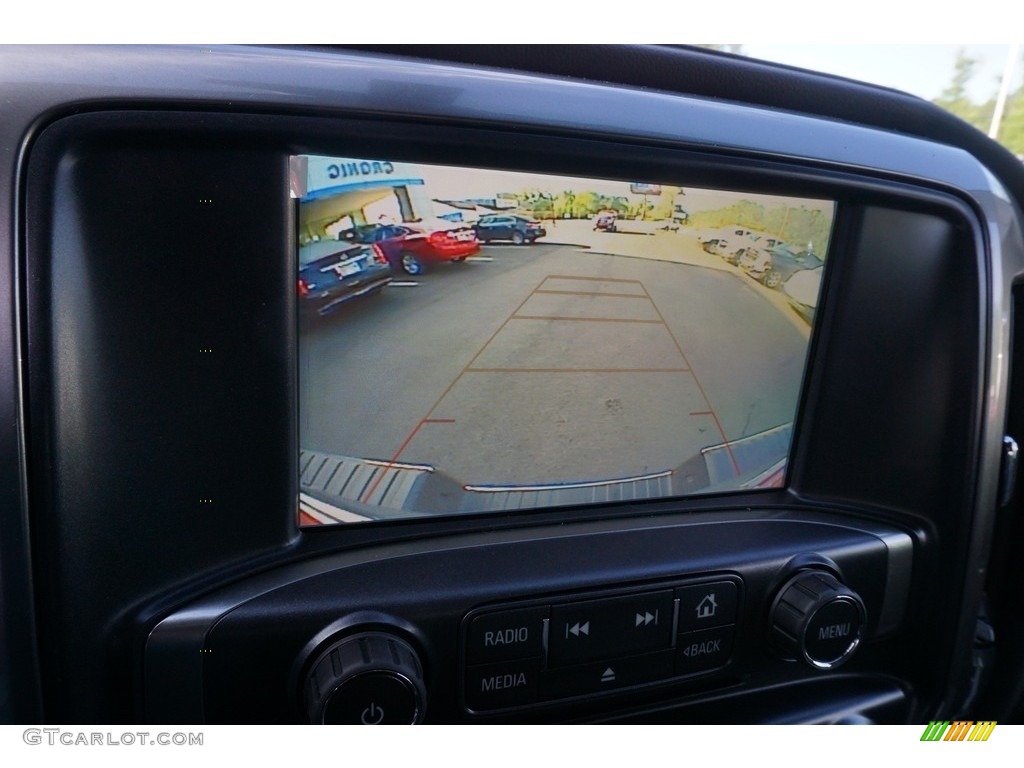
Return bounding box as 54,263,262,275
145,513,914,724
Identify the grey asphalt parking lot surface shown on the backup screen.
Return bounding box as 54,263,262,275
299,222,808,507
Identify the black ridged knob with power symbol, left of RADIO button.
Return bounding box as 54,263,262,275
304,632,426,725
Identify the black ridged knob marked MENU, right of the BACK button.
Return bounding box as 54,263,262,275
771,569,866,670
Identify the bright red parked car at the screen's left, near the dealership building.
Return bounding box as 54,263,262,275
356,224,480,274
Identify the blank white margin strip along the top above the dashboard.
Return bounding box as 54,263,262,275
8,0,1024,48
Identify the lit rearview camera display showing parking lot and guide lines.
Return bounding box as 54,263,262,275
292,156,835,525
